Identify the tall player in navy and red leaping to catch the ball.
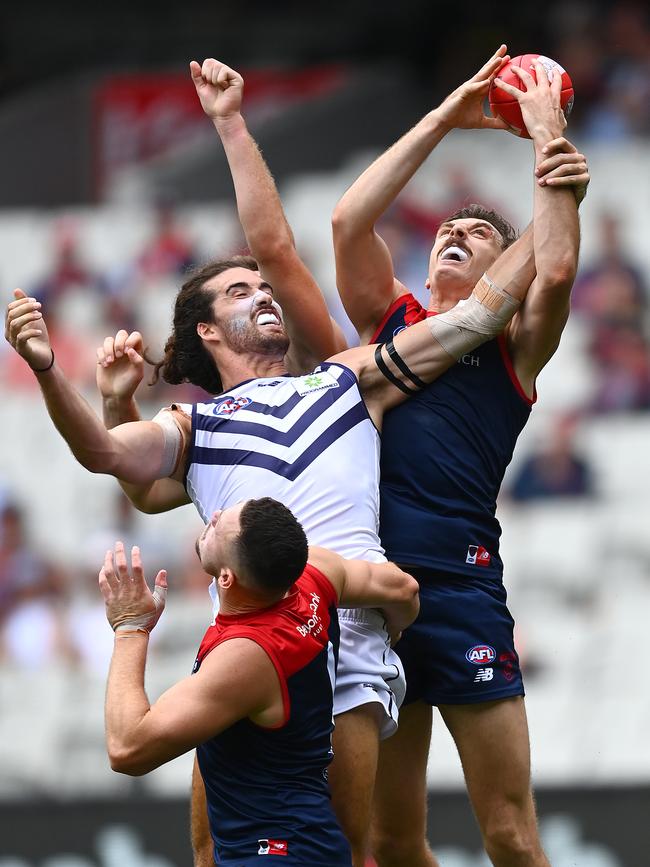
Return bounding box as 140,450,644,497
333,45,589,867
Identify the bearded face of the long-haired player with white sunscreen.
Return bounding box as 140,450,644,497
206,268,289,355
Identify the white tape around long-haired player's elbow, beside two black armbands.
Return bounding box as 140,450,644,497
427,274,520,359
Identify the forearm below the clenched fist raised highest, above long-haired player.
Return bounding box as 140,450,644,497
213,114,293,265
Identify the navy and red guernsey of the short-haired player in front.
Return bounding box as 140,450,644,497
195,564,352,867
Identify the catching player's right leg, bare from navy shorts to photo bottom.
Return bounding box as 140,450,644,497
439,696,549,867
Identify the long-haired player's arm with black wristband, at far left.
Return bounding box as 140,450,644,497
5,289,178,483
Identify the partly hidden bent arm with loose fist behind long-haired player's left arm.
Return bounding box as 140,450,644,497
97,329,190,515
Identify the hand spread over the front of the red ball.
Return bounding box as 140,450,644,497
494,59,566,142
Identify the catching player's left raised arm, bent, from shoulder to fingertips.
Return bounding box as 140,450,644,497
332,45,507,343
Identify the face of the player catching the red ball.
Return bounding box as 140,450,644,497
429,217,503,296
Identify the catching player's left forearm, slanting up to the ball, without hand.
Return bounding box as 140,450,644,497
333,110,449,234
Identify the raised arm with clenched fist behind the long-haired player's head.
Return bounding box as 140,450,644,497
190,58,346,372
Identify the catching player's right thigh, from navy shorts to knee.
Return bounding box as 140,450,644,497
439,697,535,832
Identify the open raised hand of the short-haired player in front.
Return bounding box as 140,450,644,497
99,542,167,632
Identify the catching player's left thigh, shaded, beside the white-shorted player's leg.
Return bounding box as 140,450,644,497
372,701,432,840
